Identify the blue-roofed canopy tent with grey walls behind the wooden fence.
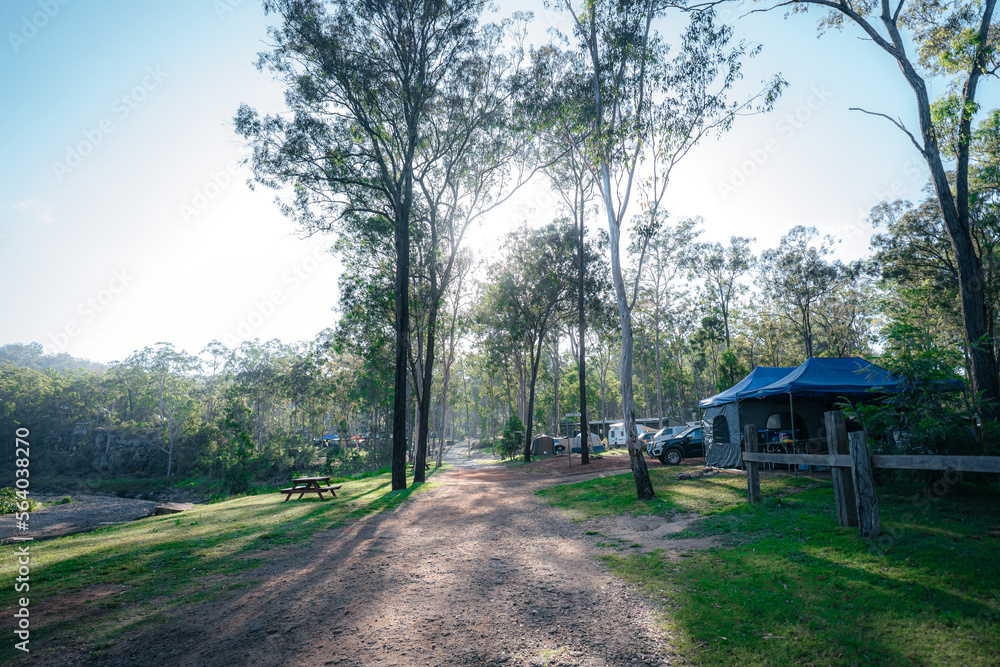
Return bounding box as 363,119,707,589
700,357,940,467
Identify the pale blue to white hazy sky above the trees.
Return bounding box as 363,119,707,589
0,0,997,362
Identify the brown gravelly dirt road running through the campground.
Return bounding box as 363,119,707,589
90,449,683,667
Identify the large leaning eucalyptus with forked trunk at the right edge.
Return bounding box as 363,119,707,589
771,0,1000,419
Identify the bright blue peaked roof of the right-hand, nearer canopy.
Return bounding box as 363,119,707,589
736,357,904,399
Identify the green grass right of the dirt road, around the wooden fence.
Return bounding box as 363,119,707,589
543,468,1000,665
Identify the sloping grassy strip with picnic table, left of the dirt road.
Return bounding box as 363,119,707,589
0,470,446,650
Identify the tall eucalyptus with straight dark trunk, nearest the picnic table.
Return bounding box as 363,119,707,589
236,0,484,490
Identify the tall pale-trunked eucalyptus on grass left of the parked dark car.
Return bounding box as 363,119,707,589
560,0,783,499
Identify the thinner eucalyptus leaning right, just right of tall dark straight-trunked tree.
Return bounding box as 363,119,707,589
411,14,545,482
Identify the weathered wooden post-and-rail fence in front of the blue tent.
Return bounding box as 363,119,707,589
743,411,1000,537
